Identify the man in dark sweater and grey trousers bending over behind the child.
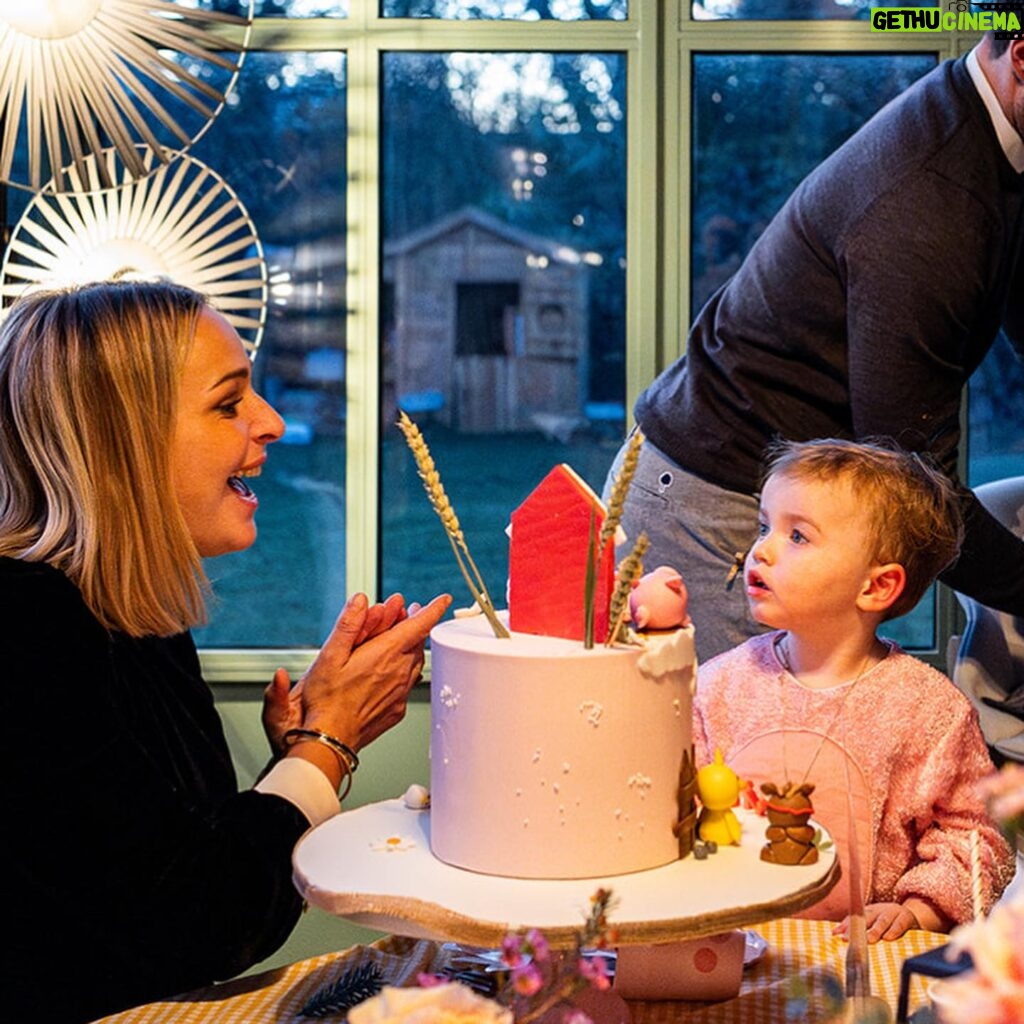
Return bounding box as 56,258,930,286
609,35,1024,658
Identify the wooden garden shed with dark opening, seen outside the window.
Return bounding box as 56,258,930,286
383,208,588,432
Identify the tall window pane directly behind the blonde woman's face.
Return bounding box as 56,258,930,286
194,52,345,647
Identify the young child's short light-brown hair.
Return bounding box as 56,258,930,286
767,438,964,618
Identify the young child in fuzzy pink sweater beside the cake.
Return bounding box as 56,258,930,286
694,440,1014,942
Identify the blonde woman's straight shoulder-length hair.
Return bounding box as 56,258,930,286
0,281,209,636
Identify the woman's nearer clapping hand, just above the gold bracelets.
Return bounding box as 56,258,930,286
299,594,452,751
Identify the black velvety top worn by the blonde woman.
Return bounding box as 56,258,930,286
0,558,308,1024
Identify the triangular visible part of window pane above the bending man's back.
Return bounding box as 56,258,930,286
690,53,936,315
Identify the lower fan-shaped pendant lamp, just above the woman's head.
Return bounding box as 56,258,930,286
0,150,267,357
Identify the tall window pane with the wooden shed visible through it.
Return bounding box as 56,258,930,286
381,53,626,605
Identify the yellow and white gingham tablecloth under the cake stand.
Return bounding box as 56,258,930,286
92,919,946,1024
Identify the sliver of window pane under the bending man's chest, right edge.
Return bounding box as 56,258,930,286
968,335,1024,487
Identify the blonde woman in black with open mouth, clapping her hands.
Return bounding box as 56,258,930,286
0,282,450,1024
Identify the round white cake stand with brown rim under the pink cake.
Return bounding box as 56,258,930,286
293,800,840,948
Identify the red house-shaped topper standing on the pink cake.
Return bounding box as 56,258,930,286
509,463,615,643
